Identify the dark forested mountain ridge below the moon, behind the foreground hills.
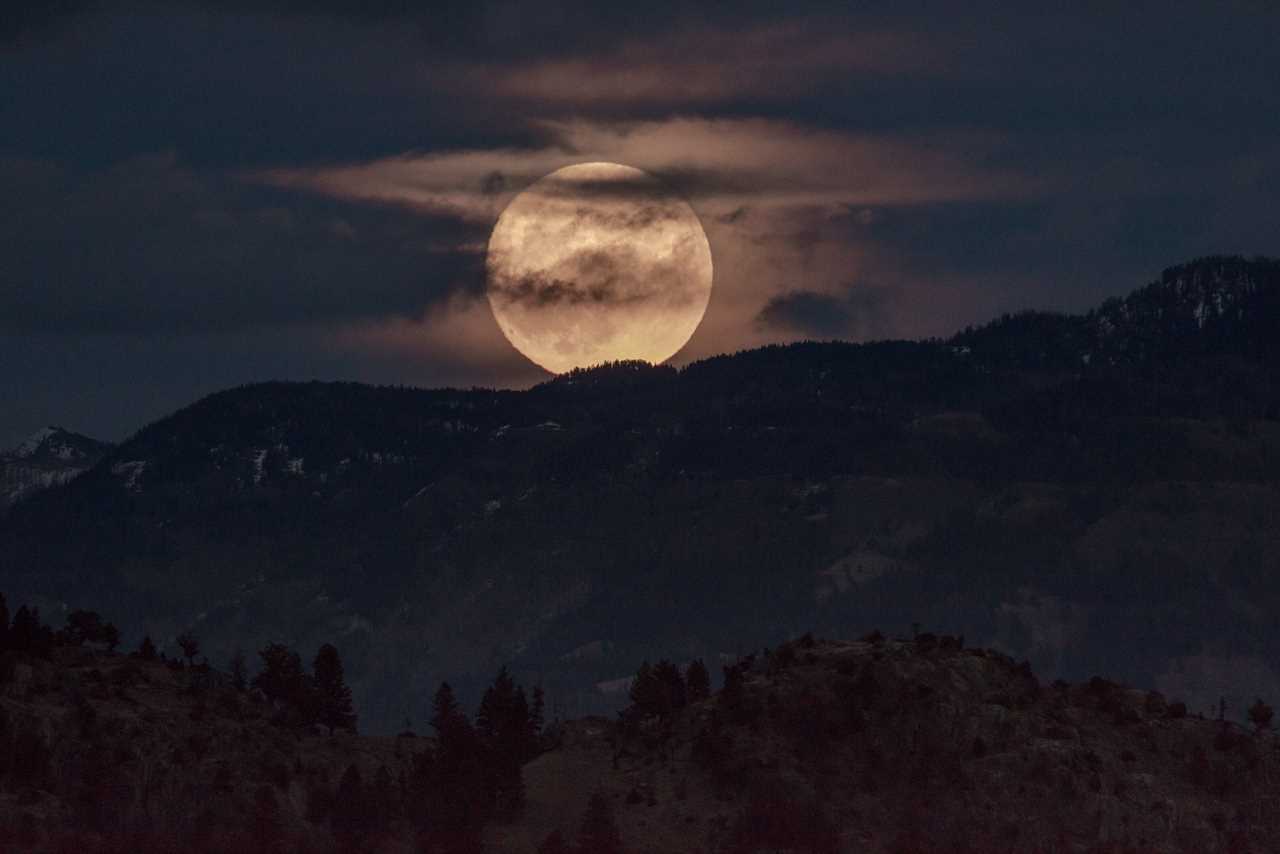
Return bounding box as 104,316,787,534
0,257,1280,732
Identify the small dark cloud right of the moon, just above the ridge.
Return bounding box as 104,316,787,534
755,287,890,341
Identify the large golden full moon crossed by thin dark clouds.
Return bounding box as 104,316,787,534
485,163,712,374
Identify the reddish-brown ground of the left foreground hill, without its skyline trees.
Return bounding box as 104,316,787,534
0,647,409,854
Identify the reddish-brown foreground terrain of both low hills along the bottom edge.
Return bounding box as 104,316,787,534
0,624,1280,854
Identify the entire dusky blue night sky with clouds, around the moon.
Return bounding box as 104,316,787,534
0,0,1280,447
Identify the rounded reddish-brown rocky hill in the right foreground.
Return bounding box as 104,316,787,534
499,635,1280,854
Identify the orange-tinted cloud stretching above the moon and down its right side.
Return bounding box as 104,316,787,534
253,118,1044,361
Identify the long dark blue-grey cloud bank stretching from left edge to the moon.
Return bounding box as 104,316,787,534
0,155,483,333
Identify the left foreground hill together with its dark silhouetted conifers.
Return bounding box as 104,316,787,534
0,597,543,854
